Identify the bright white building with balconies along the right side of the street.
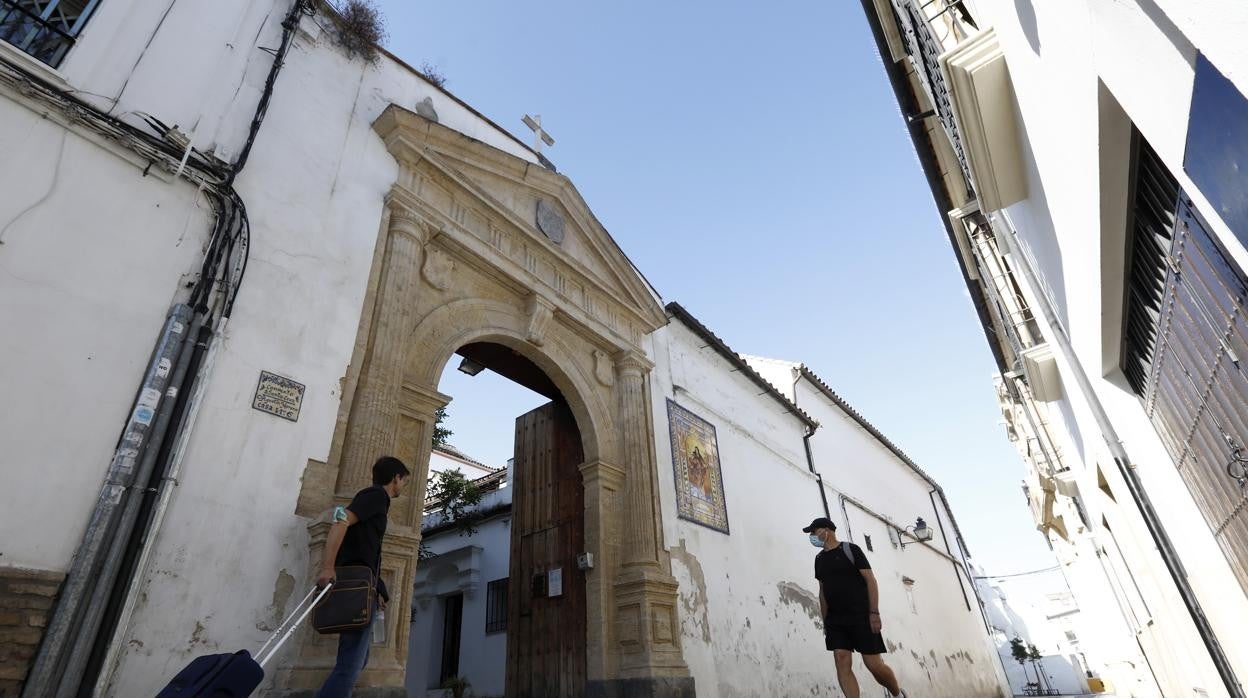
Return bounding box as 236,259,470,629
862,0,1248,697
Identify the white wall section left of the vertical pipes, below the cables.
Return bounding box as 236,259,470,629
0,99,208,571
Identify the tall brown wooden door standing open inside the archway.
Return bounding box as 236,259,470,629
507,402,585,698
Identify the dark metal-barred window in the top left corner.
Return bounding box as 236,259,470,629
0,0,100,67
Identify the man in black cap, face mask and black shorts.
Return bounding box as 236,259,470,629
801,517,906,698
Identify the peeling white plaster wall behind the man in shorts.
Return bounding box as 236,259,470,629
651,321,1003,698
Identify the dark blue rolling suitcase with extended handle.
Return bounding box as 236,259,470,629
156,584,332,698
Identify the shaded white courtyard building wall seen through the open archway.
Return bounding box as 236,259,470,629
407,489,512,698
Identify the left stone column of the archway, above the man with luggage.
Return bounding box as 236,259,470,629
337,199,429,499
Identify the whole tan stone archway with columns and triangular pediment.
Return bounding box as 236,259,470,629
283,106,694,696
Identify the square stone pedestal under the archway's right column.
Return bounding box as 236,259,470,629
615,564,693,696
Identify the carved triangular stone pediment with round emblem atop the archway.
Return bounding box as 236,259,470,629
373,105,666,347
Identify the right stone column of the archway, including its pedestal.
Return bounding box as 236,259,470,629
589,351,694,697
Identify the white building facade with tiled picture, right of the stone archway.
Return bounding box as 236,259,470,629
651,303,1006,698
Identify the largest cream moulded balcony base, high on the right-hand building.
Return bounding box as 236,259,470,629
940,29,1027,212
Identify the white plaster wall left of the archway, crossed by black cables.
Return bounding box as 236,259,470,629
0,0,534,696
